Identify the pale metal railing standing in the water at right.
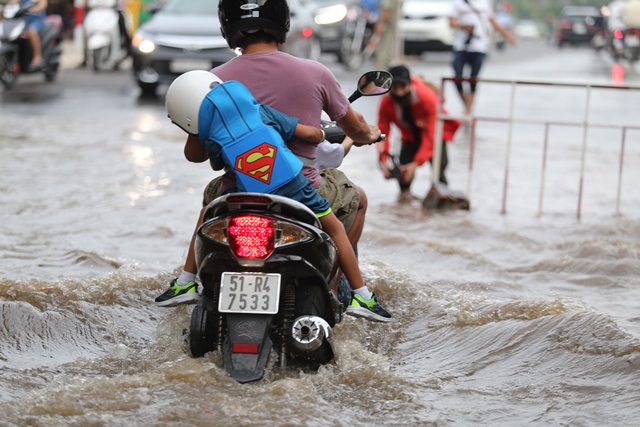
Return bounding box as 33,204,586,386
432,77,640,219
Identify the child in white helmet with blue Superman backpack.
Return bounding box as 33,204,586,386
156,71,391,322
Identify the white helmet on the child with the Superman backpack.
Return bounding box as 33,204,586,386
165,70,222,135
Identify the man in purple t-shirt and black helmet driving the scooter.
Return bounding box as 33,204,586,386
156,0,390,317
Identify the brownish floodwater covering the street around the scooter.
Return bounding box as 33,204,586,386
0,41,640,427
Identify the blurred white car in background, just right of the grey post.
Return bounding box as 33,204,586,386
399,0,454,55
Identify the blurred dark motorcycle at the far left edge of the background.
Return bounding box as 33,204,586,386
0,3,62,89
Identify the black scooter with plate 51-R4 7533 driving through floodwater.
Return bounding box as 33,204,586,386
187,71,392,383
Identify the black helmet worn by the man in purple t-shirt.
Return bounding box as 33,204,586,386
218,0,289,49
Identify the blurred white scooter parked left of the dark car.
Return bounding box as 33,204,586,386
84,0,131,72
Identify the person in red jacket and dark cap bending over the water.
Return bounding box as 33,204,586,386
378,65,459,198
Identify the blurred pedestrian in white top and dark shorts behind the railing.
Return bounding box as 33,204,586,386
449,0,516,116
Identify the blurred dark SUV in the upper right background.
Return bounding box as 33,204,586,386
555,6,601,47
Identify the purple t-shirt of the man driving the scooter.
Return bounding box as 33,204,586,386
211,52,350,187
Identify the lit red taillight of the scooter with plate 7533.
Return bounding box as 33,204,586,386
227,215,275,259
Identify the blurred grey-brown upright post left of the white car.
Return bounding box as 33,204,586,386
373,0,402,70
